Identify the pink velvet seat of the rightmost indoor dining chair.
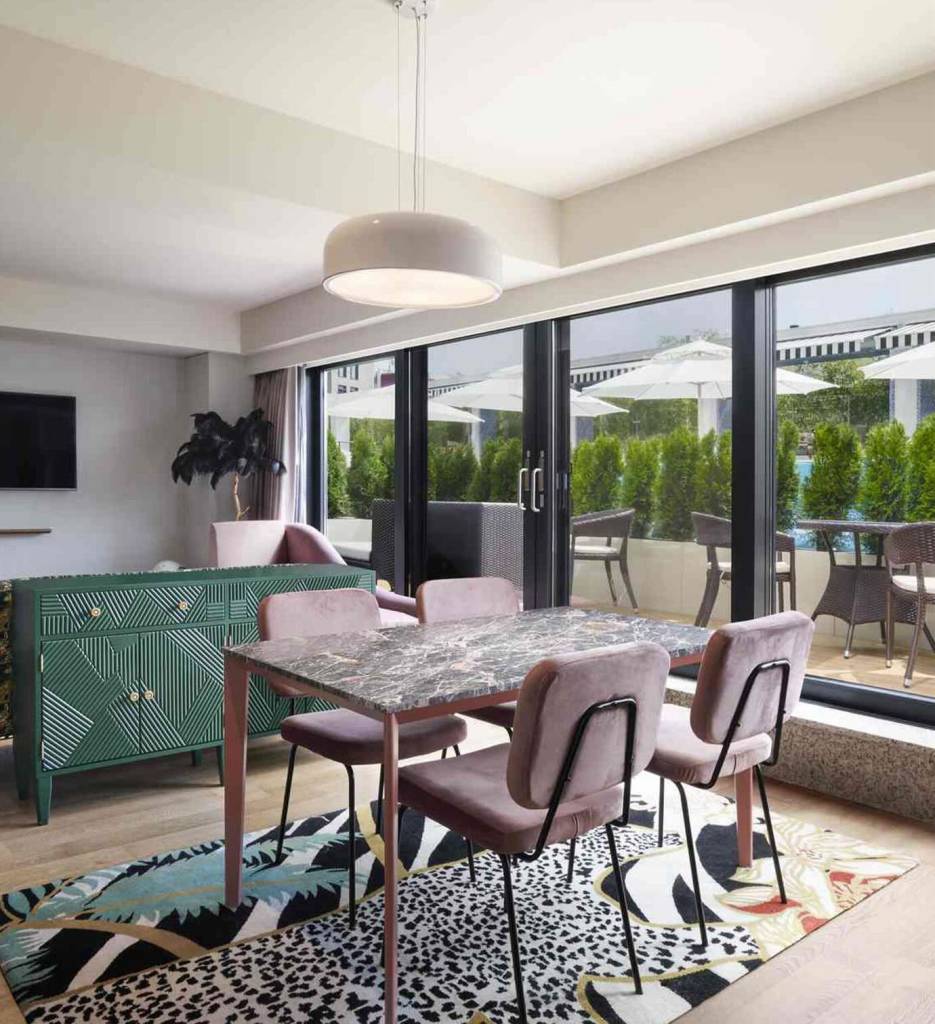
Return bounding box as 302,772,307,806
646,705,772,783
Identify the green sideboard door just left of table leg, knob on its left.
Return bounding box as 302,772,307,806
139,626,224,754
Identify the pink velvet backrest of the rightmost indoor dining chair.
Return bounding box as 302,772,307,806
691,611,815,743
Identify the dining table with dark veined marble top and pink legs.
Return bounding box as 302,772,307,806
224,608,729,1022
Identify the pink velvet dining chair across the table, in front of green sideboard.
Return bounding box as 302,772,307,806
257,590,466,928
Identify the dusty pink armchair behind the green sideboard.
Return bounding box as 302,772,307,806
211,519,418,626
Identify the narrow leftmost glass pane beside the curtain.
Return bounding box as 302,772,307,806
325,356,395,584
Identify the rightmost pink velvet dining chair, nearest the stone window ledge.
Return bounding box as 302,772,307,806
648,611,815,945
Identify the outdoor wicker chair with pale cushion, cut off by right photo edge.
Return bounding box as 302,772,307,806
883,522,935,688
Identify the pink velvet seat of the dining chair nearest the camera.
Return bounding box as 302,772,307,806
399,743,624,853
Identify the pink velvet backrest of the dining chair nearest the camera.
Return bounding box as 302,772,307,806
507,642,669,810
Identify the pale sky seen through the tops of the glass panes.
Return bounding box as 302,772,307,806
366,252,935,380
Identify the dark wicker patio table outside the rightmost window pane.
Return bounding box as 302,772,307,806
798,519,935,657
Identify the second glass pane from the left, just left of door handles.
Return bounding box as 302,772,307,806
426,331,523,592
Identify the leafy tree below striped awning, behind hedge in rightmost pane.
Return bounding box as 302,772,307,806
776,359,890,431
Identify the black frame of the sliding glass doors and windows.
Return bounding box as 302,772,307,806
306,237,935,728
